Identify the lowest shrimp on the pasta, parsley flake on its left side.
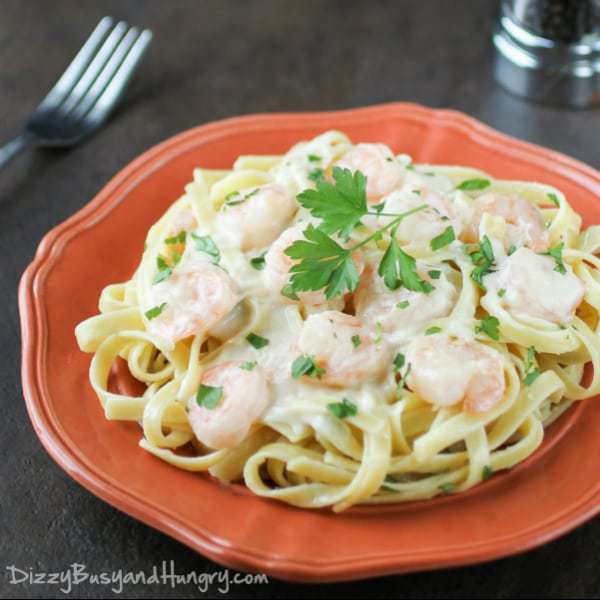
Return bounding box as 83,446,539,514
187,361,270,450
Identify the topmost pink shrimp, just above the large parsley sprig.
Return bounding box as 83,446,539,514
337,144,404,202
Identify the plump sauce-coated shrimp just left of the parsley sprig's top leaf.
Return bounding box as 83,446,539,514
217,183,298,251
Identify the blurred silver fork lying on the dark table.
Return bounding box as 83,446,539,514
0,17,152,168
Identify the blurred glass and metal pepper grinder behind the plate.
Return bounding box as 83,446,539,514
494,0,600,108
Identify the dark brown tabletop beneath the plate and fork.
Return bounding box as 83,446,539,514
0,0,600,598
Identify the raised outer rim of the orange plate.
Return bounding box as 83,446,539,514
19,102,600,582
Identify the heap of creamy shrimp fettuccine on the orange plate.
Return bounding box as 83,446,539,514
76,131,600,511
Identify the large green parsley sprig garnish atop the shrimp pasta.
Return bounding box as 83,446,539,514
285,167,432,299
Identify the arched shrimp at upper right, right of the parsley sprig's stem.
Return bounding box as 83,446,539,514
463,194,548,252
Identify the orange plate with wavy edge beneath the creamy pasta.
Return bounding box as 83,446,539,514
19,104,600,581
